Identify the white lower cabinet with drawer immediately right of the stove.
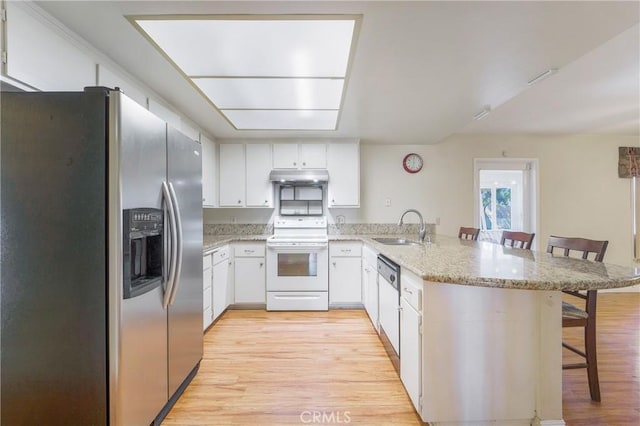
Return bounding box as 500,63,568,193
329,241,362,307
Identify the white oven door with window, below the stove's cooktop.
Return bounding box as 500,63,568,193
267,243,329,291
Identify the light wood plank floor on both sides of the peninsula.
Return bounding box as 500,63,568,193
163,293,640,426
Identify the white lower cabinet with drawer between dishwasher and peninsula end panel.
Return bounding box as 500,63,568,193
400,269,422,413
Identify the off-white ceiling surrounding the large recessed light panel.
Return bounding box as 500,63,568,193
37,1,640,144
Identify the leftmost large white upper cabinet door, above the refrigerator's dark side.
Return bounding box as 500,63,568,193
5,1,96,91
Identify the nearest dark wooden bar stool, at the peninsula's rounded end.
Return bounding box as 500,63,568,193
547,236,609,401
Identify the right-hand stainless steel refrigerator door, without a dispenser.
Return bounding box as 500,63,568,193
167,127,202,396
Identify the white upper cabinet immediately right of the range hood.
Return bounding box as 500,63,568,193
327,142,360,207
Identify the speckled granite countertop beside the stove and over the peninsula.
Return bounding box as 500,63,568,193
204,234,640,290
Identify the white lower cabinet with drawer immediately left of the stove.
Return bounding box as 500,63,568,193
233,242,267,304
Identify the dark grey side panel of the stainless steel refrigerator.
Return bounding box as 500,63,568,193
0,93,108,425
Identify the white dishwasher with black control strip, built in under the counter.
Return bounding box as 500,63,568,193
378,254,400,371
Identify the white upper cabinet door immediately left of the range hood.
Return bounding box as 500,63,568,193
245,144,273,207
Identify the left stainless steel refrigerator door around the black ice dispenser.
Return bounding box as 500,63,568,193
109,92,168,425
